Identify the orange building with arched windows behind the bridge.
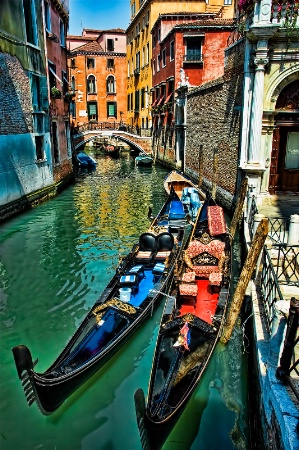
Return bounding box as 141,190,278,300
67,29,127,128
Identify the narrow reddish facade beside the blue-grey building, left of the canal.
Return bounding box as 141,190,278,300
44,0,73,182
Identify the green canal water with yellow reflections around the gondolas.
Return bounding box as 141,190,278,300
0,154,249,450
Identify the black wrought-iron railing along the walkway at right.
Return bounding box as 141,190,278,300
247,196,299,400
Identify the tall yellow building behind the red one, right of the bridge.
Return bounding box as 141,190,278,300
126,0,235,134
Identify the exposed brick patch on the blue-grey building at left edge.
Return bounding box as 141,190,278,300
0,53,33,135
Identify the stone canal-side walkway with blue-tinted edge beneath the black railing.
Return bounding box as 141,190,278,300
244,194,299,450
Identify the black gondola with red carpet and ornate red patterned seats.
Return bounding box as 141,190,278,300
134,198,231,450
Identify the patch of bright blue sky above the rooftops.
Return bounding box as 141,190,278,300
68,0,130,36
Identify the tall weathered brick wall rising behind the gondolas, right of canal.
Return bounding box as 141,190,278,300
185,38,244,205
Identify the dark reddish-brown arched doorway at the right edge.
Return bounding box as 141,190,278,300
269,79,299,194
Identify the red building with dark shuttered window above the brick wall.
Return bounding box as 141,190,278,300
151,13,234,165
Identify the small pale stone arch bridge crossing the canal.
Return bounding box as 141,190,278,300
72,130,152,155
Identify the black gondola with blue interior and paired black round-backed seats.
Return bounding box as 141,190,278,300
12,174,204,414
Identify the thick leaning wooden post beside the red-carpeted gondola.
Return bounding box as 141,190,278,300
220,218,268,344
